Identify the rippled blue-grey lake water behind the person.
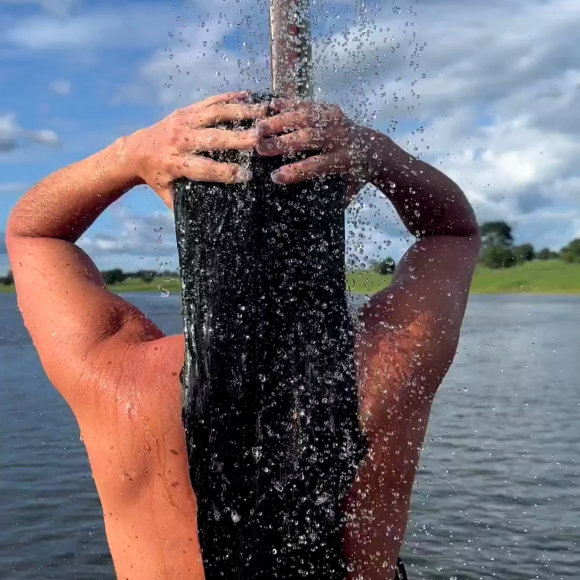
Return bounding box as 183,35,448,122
0,294,580,580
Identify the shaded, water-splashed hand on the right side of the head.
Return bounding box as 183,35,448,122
256,99,379,202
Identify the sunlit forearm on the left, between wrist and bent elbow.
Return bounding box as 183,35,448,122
6,139,136,242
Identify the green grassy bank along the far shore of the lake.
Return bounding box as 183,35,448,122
0,260,580,294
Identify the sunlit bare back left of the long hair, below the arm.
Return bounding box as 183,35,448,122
74,337,203,580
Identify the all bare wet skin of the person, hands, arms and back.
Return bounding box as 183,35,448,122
6,92,480,580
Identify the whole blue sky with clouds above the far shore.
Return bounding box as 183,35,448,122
0,0,580,273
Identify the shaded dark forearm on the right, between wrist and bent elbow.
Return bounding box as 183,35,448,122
372,134,478,237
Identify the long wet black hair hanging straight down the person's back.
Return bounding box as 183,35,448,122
175,96,365,580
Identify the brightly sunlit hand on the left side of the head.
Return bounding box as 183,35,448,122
124,91,268,208
